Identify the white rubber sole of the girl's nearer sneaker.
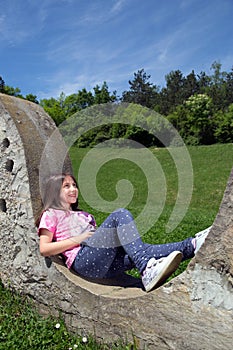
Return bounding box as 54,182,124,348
145,251,183,292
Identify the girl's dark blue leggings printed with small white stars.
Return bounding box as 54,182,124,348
72,209,194,278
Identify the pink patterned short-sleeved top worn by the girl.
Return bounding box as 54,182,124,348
38,208,96,268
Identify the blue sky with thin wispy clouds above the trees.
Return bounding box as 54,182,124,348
0,0,233,99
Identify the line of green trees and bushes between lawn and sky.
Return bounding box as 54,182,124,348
0,62,233,147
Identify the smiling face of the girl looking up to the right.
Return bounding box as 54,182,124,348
60,176,78,210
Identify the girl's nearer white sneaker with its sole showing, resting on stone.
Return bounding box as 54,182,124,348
142,251,183,292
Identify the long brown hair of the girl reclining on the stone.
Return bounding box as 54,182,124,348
36,173,79,227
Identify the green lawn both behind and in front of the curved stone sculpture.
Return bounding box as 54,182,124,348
0,144,233,350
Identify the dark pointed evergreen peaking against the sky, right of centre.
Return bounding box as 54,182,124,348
121,69,158,108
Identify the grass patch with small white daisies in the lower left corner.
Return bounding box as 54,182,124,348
0,283,134,350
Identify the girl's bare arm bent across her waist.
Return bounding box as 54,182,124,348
40,229,93,256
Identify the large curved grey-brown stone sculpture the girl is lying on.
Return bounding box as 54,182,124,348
0,94,233,350
